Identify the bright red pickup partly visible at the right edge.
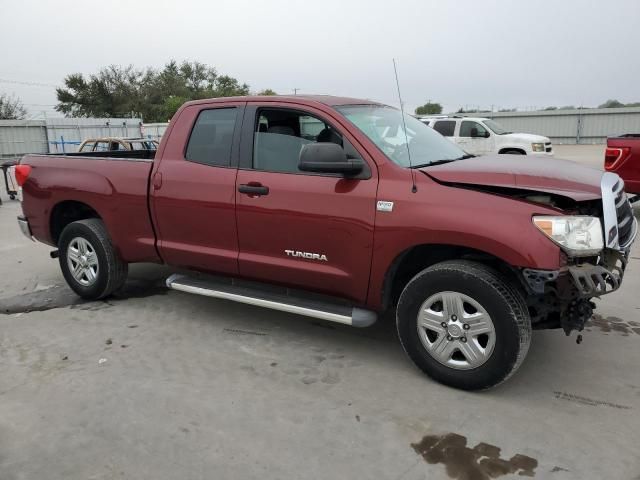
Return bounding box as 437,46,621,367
604,134,640,194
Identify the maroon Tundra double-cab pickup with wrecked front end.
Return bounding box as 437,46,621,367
16,96,637,389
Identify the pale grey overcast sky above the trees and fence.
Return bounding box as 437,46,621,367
0,0,640,114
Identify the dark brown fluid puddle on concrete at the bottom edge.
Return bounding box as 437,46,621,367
411,433,538,480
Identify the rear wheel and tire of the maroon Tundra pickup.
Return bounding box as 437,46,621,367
58,218,128,300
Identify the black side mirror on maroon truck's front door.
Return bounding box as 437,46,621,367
298,143,364,176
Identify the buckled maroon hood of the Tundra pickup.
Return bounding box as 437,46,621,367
420,155,603,202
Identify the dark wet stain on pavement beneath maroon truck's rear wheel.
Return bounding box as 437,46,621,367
0,278,169,315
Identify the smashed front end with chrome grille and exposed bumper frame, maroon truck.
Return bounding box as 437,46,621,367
521,173,638,338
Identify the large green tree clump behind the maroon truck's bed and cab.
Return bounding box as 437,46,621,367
56,60,258,122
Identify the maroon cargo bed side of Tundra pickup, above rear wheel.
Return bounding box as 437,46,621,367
21,150,159,262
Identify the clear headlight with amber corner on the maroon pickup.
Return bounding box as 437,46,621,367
533,215,604,257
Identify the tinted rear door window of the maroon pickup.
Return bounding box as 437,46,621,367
185,108,237,167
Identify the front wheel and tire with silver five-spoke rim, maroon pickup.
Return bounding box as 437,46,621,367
396,260,531,390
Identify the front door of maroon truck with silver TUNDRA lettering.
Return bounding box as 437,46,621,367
236,103,377,302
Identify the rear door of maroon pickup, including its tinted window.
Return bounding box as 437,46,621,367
150,102,244,275
